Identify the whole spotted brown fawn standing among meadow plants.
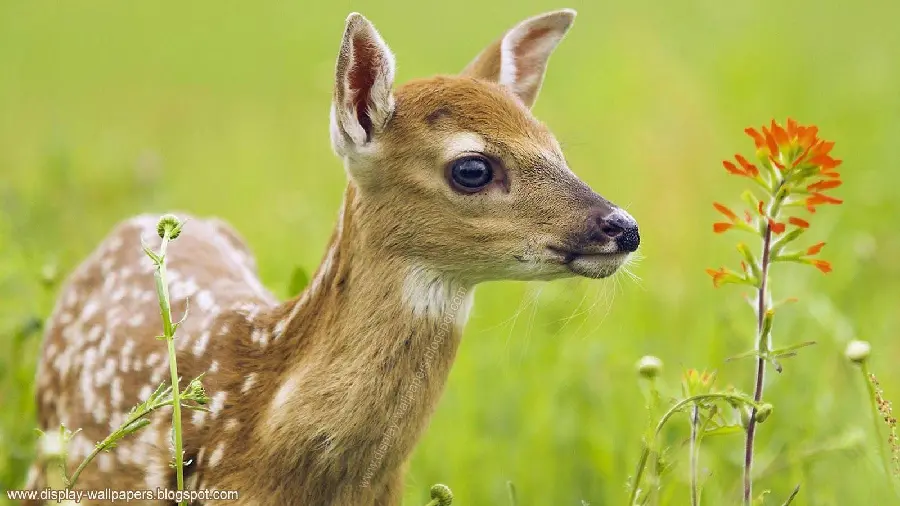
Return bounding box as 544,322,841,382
31,10,639,506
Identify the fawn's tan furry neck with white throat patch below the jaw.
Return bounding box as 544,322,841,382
262,184,472,485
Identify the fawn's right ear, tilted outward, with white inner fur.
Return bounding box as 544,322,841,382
462,9,575,107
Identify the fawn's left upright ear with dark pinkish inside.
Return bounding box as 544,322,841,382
331,12,395,156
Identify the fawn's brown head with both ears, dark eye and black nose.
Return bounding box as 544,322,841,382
331,10,640,283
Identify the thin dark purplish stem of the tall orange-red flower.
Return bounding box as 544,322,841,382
744,220,772,506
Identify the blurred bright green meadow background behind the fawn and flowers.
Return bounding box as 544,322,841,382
0,0,900,506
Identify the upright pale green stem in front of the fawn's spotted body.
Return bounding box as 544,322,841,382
154,229,187,505
